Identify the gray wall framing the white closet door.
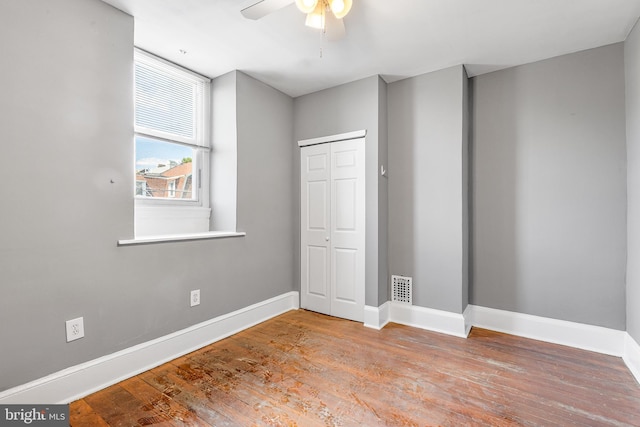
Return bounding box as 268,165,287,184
292,76,388,307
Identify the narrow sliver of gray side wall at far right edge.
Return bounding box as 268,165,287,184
624,23,640,343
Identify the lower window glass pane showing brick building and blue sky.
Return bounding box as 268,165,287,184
135,136,195,200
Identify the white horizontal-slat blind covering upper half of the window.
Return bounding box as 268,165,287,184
134,51,209,147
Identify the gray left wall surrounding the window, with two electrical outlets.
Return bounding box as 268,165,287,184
0,0,294,391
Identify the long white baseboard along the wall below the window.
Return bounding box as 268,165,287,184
0,292,300,404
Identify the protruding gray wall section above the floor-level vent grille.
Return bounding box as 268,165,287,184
388,66,468,313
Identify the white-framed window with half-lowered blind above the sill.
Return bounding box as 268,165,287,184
134,50,211,236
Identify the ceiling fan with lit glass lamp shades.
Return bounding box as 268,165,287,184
240,0,352,40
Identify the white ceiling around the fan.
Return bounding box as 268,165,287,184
103,0,640,97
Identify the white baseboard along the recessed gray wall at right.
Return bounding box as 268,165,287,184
468,305,626,357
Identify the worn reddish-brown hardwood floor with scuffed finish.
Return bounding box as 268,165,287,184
70,310,640,427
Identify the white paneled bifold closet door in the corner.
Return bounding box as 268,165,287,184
301,139,365,321
